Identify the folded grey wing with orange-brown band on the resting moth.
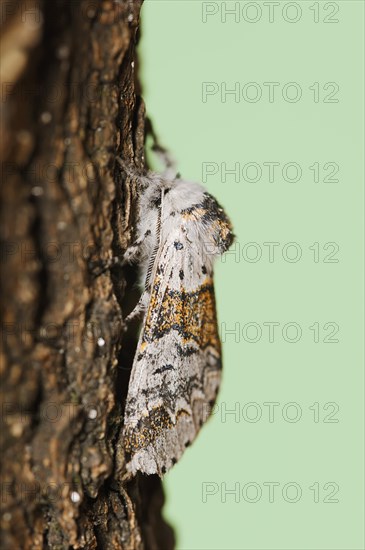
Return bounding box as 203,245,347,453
124,227,221,475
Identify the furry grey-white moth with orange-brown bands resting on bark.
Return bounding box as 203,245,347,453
119,160,233,476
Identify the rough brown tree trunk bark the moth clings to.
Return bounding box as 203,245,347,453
0,0,173,550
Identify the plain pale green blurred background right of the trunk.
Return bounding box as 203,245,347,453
139,0,364,550
